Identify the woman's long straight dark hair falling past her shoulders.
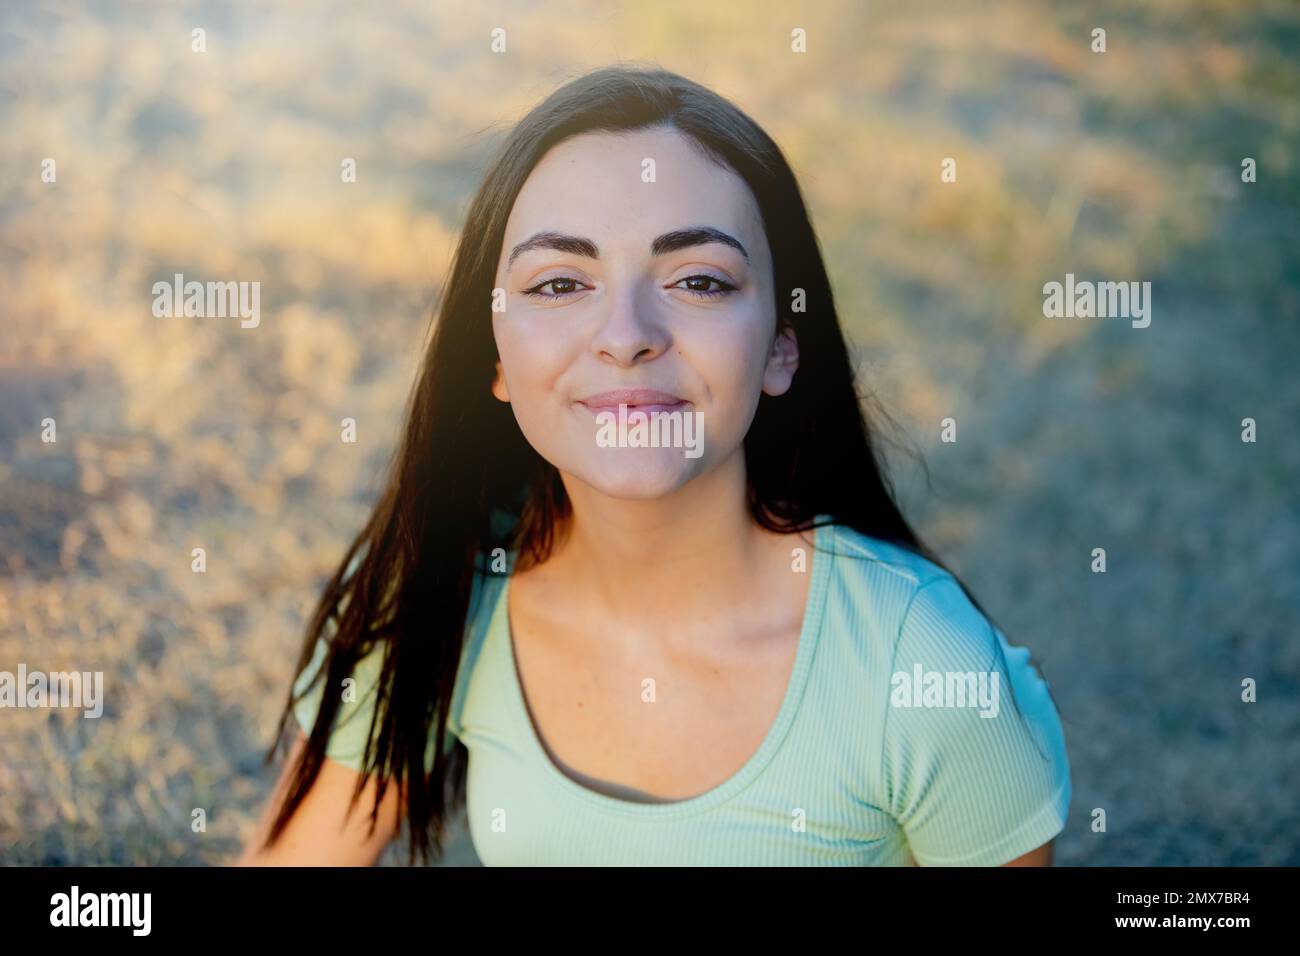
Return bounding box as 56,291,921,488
256,59,1055,862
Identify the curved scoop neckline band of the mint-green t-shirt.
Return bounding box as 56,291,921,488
491,515,832,817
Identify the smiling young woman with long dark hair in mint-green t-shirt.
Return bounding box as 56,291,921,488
239,66,1071,865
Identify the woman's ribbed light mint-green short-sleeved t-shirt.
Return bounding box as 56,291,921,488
296,525,1071,866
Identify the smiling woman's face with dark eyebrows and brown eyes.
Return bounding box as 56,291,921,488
493,127,798,499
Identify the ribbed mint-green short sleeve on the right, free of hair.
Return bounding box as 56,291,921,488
881,574,1071,866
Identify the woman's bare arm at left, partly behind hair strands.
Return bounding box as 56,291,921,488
231,730,402,866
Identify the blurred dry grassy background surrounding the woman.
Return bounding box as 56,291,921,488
0,0,1300,865
